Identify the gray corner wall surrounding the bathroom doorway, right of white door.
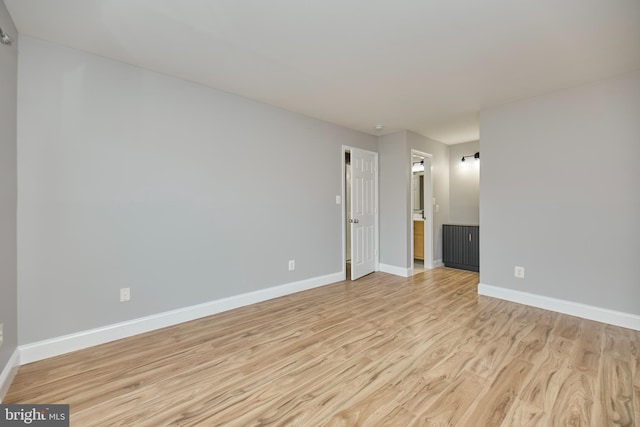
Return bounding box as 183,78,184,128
378,131,449,268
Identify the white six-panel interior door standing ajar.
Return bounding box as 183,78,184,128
350,149,378,280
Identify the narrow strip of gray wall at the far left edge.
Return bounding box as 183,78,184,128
0,1,18,380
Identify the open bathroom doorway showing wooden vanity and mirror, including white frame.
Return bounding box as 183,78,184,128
409,150,433,274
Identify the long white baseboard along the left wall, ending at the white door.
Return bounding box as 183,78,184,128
18,273,344,364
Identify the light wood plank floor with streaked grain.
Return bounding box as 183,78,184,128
5,268,640,427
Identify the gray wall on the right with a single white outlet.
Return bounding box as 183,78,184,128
480,73,640,314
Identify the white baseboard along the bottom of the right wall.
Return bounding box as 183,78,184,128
478,283,640,331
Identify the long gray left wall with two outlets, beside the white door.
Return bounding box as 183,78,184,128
18,37,377,344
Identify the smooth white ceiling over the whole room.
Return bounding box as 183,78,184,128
4,0,640,144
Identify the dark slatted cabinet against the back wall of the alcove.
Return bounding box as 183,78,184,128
442,224,480,271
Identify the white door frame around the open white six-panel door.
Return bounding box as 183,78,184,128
340,145,380,280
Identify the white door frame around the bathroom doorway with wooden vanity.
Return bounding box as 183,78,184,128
408,149,434,274
